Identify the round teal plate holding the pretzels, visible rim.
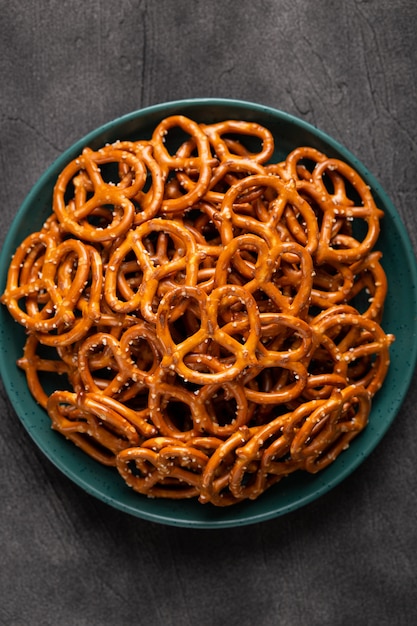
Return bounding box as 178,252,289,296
0,99,417,528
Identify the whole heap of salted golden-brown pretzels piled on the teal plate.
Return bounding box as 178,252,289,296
1,115,394,507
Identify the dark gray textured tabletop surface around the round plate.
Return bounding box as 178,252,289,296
0,0,417,626
